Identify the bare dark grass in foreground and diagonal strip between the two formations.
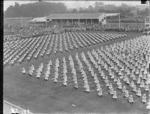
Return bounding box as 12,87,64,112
3,30,149,114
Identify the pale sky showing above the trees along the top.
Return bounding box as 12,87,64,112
3,0,146,11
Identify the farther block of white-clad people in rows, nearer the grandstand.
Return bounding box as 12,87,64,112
3,32,126,65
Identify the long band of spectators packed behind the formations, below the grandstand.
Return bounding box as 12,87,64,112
4,19,148,40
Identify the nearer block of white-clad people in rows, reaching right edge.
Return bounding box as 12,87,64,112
22,36,150,109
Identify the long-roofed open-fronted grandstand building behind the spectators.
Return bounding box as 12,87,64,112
47,13,119,24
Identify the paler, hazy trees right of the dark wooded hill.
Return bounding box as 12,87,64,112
71,2,150,16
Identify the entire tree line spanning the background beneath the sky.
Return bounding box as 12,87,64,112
4,2,150,17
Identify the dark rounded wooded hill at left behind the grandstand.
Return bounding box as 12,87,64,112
4,2,67,18
